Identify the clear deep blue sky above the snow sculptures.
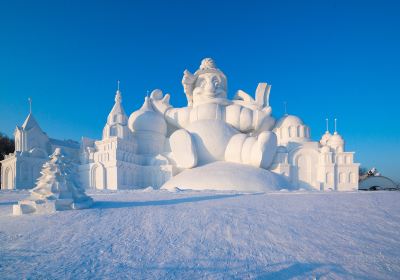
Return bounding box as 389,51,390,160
0,0,400,181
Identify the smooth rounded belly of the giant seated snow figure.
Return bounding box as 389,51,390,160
186,120,238,164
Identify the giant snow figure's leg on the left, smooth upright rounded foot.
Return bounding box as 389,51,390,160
169,129,197,168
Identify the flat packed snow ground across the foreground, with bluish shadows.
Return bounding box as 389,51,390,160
0,190,400,279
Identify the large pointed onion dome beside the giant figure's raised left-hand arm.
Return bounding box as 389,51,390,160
128,97,167,135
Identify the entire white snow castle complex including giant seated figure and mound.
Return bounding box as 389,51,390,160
1,58,359,191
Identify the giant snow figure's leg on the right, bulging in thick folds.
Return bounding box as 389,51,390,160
225,131,277,169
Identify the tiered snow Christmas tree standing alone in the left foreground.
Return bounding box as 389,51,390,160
13,148,93,215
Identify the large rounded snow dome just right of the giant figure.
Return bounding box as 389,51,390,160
274,114,310,146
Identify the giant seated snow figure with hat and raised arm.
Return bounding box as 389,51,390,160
150,58,277,169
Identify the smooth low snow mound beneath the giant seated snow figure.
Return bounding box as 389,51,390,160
161,161,293,192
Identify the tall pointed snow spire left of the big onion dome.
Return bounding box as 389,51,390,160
103,81,130,139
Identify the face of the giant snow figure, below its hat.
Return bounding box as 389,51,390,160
193,73,226,104
